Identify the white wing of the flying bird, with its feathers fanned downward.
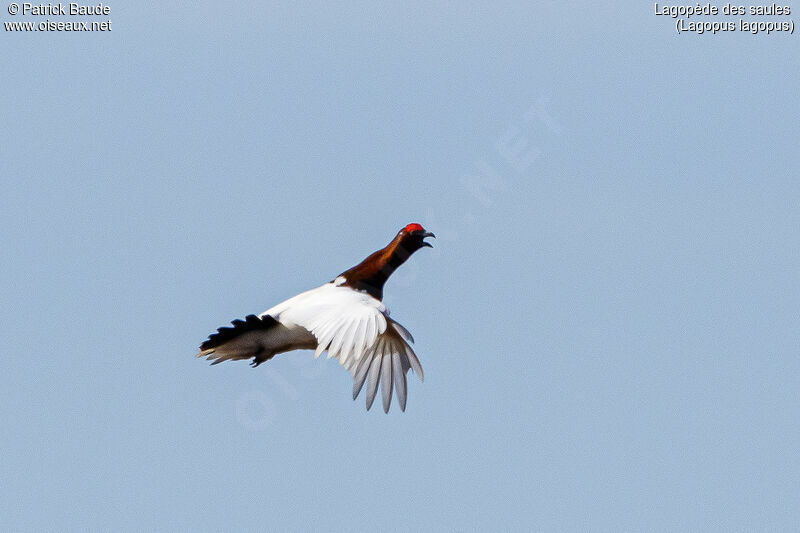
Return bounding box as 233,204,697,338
261,279,423,412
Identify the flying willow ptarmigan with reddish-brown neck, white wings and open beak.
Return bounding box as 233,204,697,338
197,224,435,413
